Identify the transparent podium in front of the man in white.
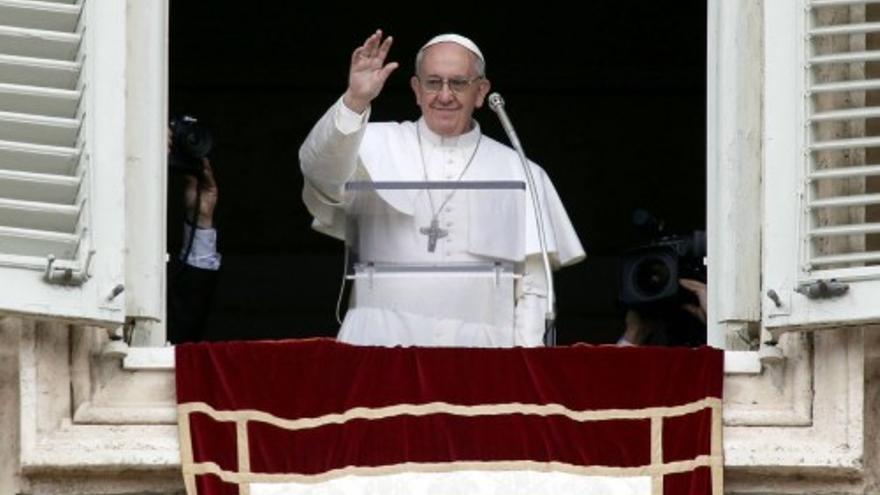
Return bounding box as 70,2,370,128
344,181,526,346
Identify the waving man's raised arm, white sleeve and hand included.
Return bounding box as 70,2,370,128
299,31,398,203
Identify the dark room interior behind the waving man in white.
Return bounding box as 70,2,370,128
168,0,706,343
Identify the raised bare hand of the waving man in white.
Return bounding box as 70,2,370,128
342,29,399,113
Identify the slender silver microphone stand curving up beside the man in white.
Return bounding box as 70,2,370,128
489,93,556,347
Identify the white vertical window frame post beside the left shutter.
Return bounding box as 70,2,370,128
125,1,168,340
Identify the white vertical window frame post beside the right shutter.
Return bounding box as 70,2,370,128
706,0,762,347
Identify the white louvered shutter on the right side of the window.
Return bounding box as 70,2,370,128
763,0,880,334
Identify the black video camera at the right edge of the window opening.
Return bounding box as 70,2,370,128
619,231,706,308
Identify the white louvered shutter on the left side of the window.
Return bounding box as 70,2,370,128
0,0,126,323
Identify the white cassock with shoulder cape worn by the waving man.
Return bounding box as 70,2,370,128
299,99,585,347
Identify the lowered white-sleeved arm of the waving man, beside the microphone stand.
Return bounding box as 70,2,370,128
514,255,547,347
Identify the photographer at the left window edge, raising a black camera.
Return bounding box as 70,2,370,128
167,121,221,344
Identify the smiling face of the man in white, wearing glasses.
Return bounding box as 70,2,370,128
410,43,490,137
